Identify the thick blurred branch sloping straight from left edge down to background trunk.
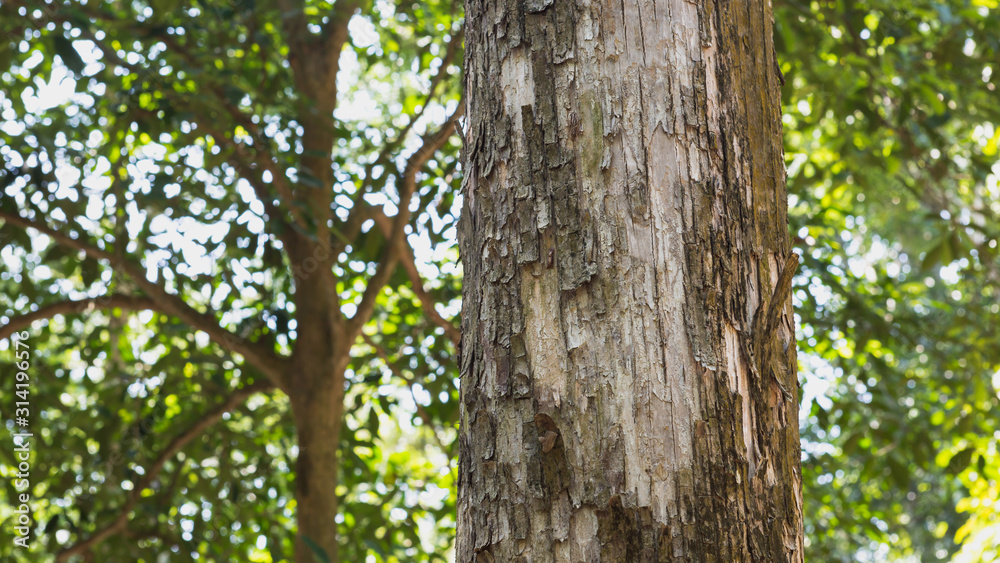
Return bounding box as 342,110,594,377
0,210,287,388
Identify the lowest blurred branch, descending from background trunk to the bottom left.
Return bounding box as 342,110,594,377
56,381,273,563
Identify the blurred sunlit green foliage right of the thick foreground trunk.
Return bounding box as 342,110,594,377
775,0,1000,561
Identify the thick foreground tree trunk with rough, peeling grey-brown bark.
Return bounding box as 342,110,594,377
457,0,803,563
